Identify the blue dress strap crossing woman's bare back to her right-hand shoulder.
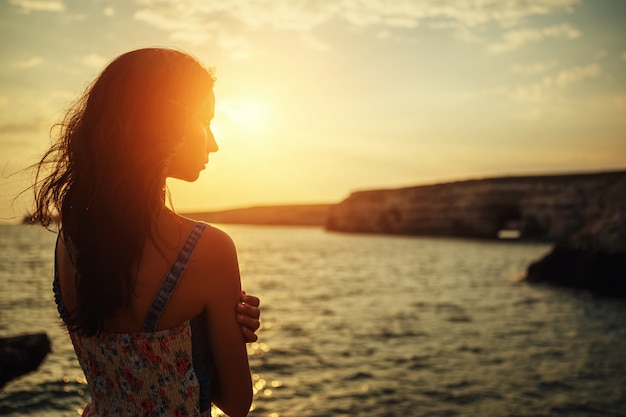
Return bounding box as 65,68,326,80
143,222,209,333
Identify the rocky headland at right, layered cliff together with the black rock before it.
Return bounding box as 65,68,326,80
326,171,626,296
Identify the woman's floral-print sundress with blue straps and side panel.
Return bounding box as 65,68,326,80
53,223,213,417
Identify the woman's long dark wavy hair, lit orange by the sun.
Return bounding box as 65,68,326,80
33,48,214,335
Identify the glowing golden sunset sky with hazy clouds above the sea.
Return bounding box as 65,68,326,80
0,0,626,221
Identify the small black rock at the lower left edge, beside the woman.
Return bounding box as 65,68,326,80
0,333,50,388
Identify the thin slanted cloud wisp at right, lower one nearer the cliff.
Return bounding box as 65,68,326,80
509,64,603,103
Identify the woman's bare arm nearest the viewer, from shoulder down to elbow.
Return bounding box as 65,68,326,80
201,228,252,417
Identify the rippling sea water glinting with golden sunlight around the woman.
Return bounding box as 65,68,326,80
0,225,626,417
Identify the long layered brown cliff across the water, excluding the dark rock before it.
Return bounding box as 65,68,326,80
326,171,626,241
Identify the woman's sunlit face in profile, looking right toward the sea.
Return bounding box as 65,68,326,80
166,92,218,182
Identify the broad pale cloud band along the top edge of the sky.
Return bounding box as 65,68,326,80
133,0,581,56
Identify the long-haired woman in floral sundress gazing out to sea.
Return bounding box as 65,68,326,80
34,48,259,416
